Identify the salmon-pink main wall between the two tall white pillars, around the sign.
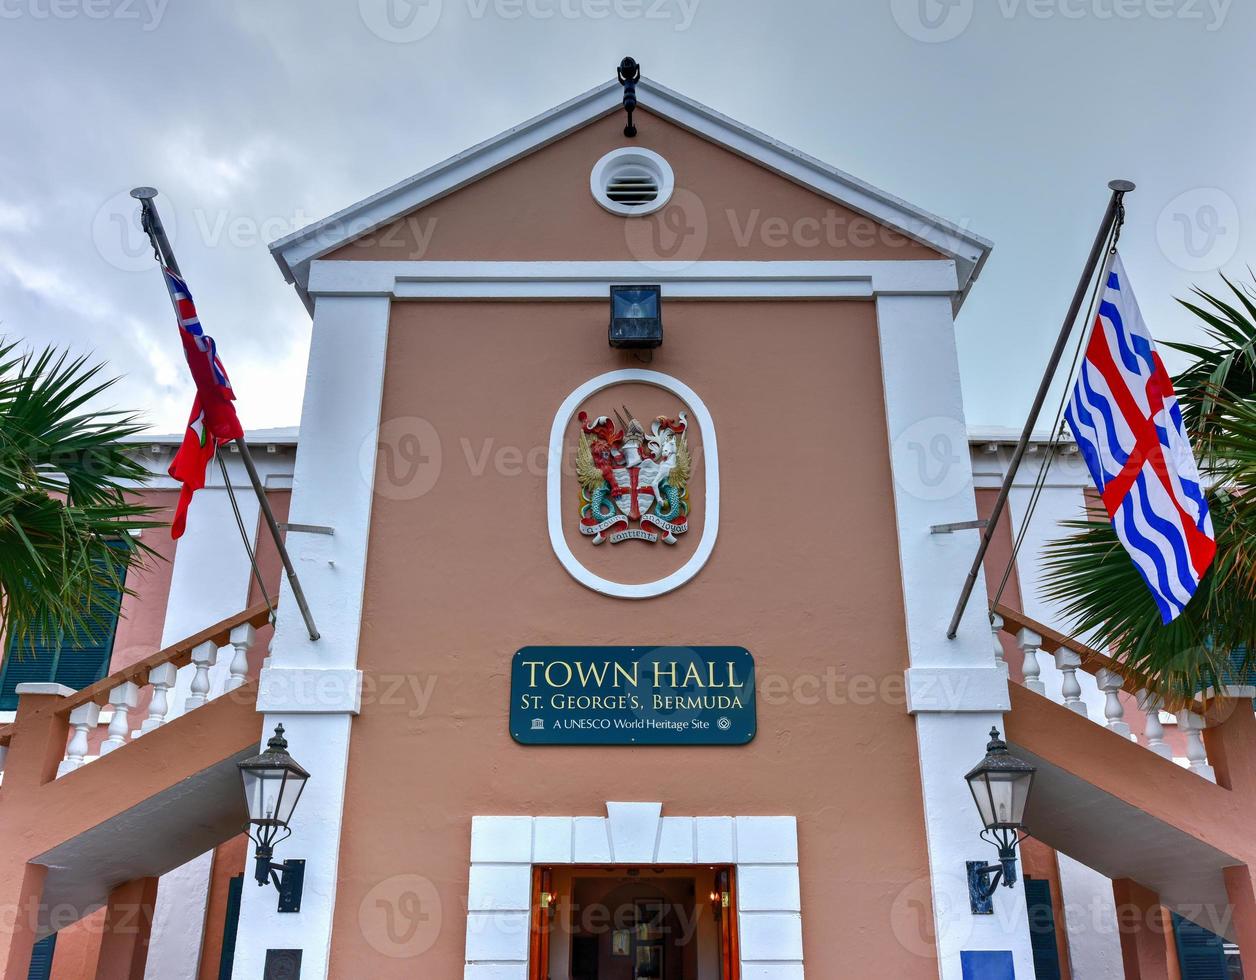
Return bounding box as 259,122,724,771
330,302,937,979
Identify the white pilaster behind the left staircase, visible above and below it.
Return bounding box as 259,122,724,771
144,474,257,980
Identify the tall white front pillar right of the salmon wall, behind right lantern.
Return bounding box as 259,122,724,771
877,297,1034,980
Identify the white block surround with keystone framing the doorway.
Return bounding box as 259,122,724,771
463,803,804,980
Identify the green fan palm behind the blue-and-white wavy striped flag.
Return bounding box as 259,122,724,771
1046,276,1256,694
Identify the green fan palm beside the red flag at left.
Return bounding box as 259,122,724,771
0,342,160,653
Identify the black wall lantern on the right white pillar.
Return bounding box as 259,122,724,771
965,729,1037,915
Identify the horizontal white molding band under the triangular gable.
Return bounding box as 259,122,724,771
308,259,960,300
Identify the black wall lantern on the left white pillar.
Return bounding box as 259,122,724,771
237,725,310,912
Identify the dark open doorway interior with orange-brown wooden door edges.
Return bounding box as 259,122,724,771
528,864,741,980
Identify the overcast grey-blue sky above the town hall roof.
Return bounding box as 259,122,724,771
0,0,1256,432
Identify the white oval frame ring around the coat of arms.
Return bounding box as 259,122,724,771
545,368,720,599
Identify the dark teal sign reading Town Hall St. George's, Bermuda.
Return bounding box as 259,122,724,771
510,647,756,745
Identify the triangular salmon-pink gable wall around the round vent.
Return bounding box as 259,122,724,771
327,111,941,261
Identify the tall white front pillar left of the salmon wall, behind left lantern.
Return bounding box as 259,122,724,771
235,297,389,980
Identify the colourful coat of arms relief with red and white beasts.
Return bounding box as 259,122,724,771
575,407,691,544
